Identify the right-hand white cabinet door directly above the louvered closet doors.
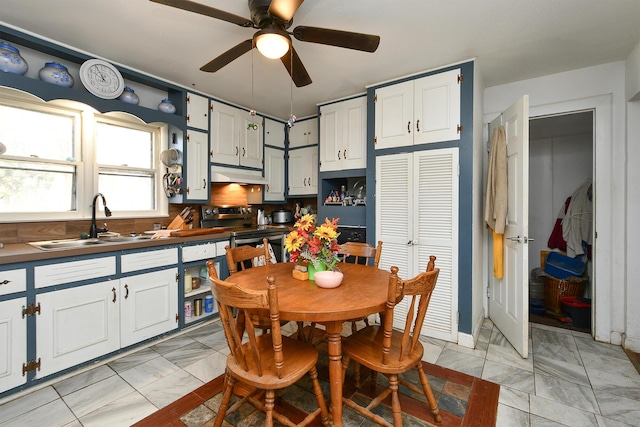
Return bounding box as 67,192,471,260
413,69,460,145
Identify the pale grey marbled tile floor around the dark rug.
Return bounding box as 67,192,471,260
0,320,640,427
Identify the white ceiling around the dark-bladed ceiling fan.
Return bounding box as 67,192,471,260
0,0,640,120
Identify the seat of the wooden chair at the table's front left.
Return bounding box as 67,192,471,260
227,333,318,390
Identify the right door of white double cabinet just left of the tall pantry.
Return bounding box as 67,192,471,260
338,97,367,169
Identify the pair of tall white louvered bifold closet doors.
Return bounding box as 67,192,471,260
376,148,458,341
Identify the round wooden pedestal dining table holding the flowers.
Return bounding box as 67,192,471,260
226,262,390,426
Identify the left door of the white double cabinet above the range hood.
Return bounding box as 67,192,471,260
209,101,240,166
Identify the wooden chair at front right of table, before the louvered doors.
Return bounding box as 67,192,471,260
342,256,442,426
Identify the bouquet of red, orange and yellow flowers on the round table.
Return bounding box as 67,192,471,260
285,214,340,280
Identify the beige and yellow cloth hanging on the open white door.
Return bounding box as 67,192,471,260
484,126,507,279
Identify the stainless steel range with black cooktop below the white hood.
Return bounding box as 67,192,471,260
200,206,288,262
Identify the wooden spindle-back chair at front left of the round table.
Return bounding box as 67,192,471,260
210,271,329,427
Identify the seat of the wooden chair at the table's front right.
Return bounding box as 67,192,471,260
342,325,424,374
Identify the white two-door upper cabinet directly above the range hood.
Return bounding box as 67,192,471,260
210,101,263,169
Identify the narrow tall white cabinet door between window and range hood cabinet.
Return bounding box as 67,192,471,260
185,130,209,201
